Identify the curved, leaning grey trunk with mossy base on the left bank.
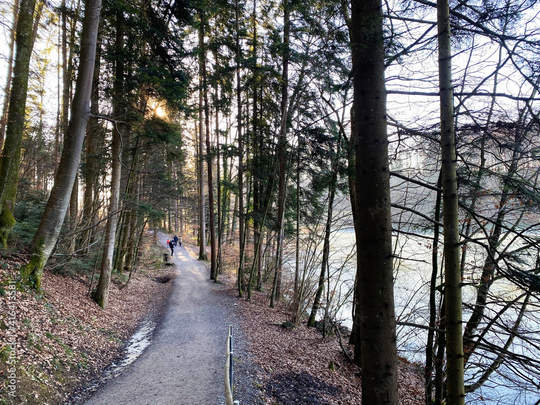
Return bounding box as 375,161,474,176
21,0,101,289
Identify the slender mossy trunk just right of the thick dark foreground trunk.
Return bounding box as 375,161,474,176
437,0,465,405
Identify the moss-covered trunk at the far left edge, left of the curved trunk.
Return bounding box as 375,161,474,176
0,0,35,247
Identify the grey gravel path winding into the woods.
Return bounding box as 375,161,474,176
86,235,235,405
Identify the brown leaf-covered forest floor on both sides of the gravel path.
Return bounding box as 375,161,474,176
0,234,423,405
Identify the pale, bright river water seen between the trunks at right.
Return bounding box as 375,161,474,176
289,229,540,405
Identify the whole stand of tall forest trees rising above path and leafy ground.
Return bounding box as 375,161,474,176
0,0,540,405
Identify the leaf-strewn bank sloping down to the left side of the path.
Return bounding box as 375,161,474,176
0,237,173,405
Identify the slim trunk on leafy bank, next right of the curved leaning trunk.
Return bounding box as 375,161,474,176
92,11,124,309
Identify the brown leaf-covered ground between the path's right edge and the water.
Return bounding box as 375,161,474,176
216,238,424,405
